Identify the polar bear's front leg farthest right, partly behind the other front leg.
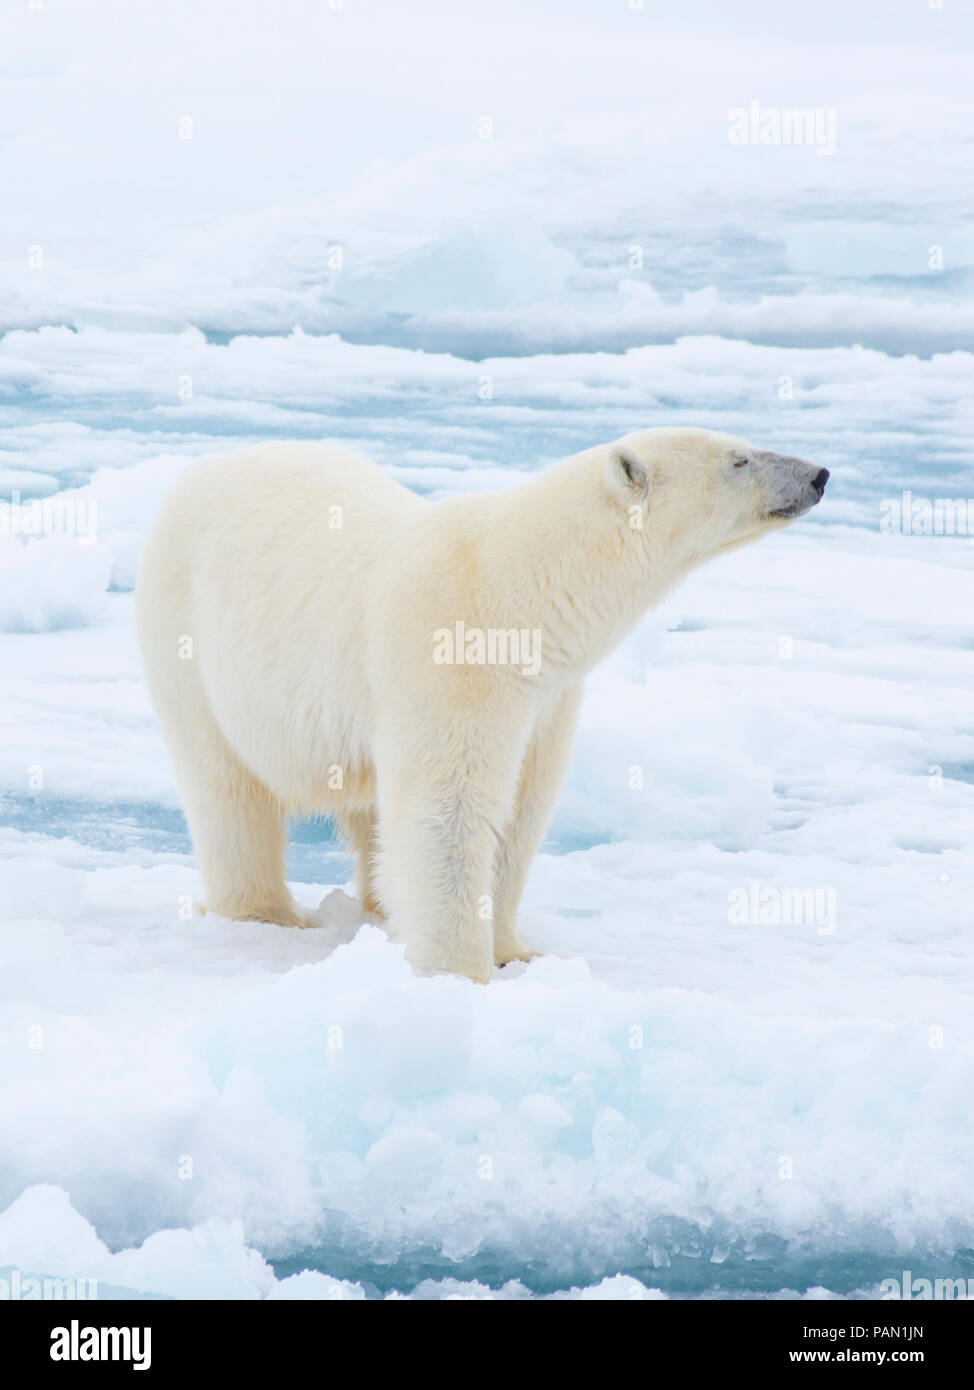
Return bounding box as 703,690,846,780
493,684,582,965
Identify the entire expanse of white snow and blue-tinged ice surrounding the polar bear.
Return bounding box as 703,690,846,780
0,0,974,1300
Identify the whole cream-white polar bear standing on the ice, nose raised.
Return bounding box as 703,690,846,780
138,428,828,981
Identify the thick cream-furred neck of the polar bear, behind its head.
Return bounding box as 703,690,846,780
479,449,693,678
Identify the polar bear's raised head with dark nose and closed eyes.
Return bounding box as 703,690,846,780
604,430,828,564
